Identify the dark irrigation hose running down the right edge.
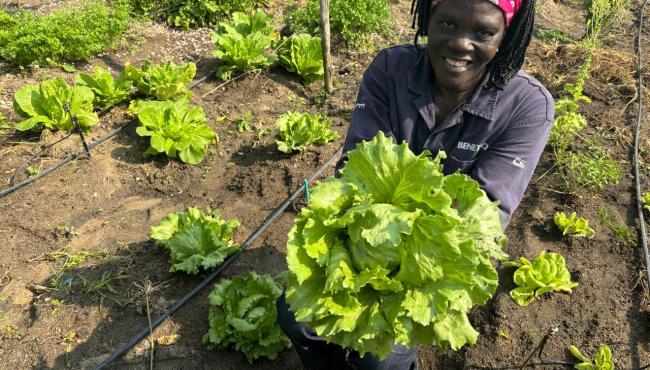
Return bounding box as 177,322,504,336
633,0,650,304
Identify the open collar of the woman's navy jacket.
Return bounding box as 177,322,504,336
407,48,499,121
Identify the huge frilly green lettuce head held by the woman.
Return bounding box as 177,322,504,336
287,133,506,359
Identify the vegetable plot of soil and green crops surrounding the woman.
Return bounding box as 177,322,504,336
0,0,650,370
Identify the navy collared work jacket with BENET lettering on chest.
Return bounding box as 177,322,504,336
339,45,554,228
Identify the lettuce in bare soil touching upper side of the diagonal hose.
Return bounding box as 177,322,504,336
149,207,240,274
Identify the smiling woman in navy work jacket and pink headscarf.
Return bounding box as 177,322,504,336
278,0,554,370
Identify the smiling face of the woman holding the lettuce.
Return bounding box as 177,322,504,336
428,0,505,92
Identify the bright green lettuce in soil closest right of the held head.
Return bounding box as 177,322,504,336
506,251,578,306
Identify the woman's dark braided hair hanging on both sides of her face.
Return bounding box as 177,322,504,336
411,0,535,88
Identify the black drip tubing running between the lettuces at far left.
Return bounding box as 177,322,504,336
0,67,232,198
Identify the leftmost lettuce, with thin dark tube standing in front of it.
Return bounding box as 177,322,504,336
13,77,99,132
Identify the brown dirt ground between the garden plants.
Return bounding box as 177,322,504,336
0,0,650,369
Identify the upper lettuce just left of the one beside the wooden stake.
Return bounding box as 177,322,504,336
212,10,279,80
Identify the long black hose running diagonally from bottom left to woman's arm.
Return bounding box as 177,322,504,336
95,147,343,370
